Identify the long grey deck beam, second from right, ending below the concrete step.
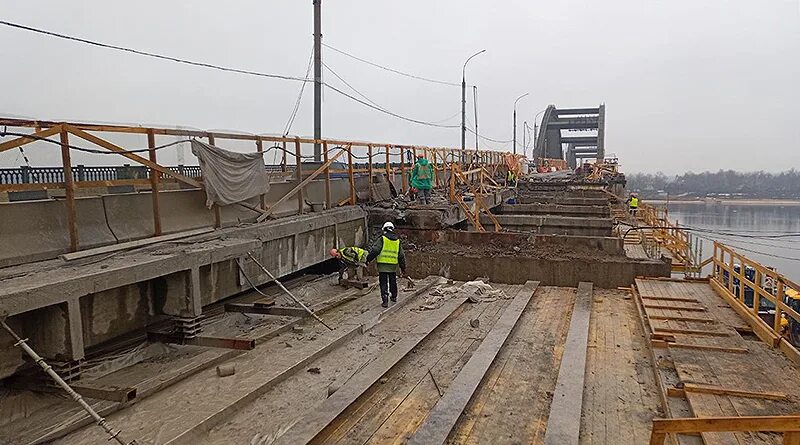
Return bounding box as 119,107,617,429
408,281,539,445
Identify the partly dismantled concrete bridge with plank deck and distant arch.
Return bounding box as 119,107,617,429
0,115,800,445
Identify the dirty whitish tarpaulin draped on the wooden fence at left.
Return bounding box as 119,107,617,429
192,139,269,208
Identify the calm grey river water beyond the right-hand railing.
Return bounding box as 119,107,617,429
653,202,800,282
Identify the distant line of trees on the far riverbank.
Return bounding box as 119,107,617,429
625,169,800,199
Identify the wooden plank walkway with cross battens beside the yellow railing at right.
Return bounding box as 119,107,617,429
636,279,800,444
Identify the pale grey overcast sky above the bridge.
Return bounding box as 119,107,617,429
0,0,800,174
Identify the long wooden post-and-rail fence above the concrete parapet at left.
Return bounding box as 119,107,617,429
0,119,510,251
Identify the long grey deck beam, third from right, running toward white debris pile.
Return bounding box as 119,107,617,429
273,298,466,445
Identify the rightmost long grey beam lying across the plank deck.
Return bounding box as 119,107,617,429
544,282,592,445
